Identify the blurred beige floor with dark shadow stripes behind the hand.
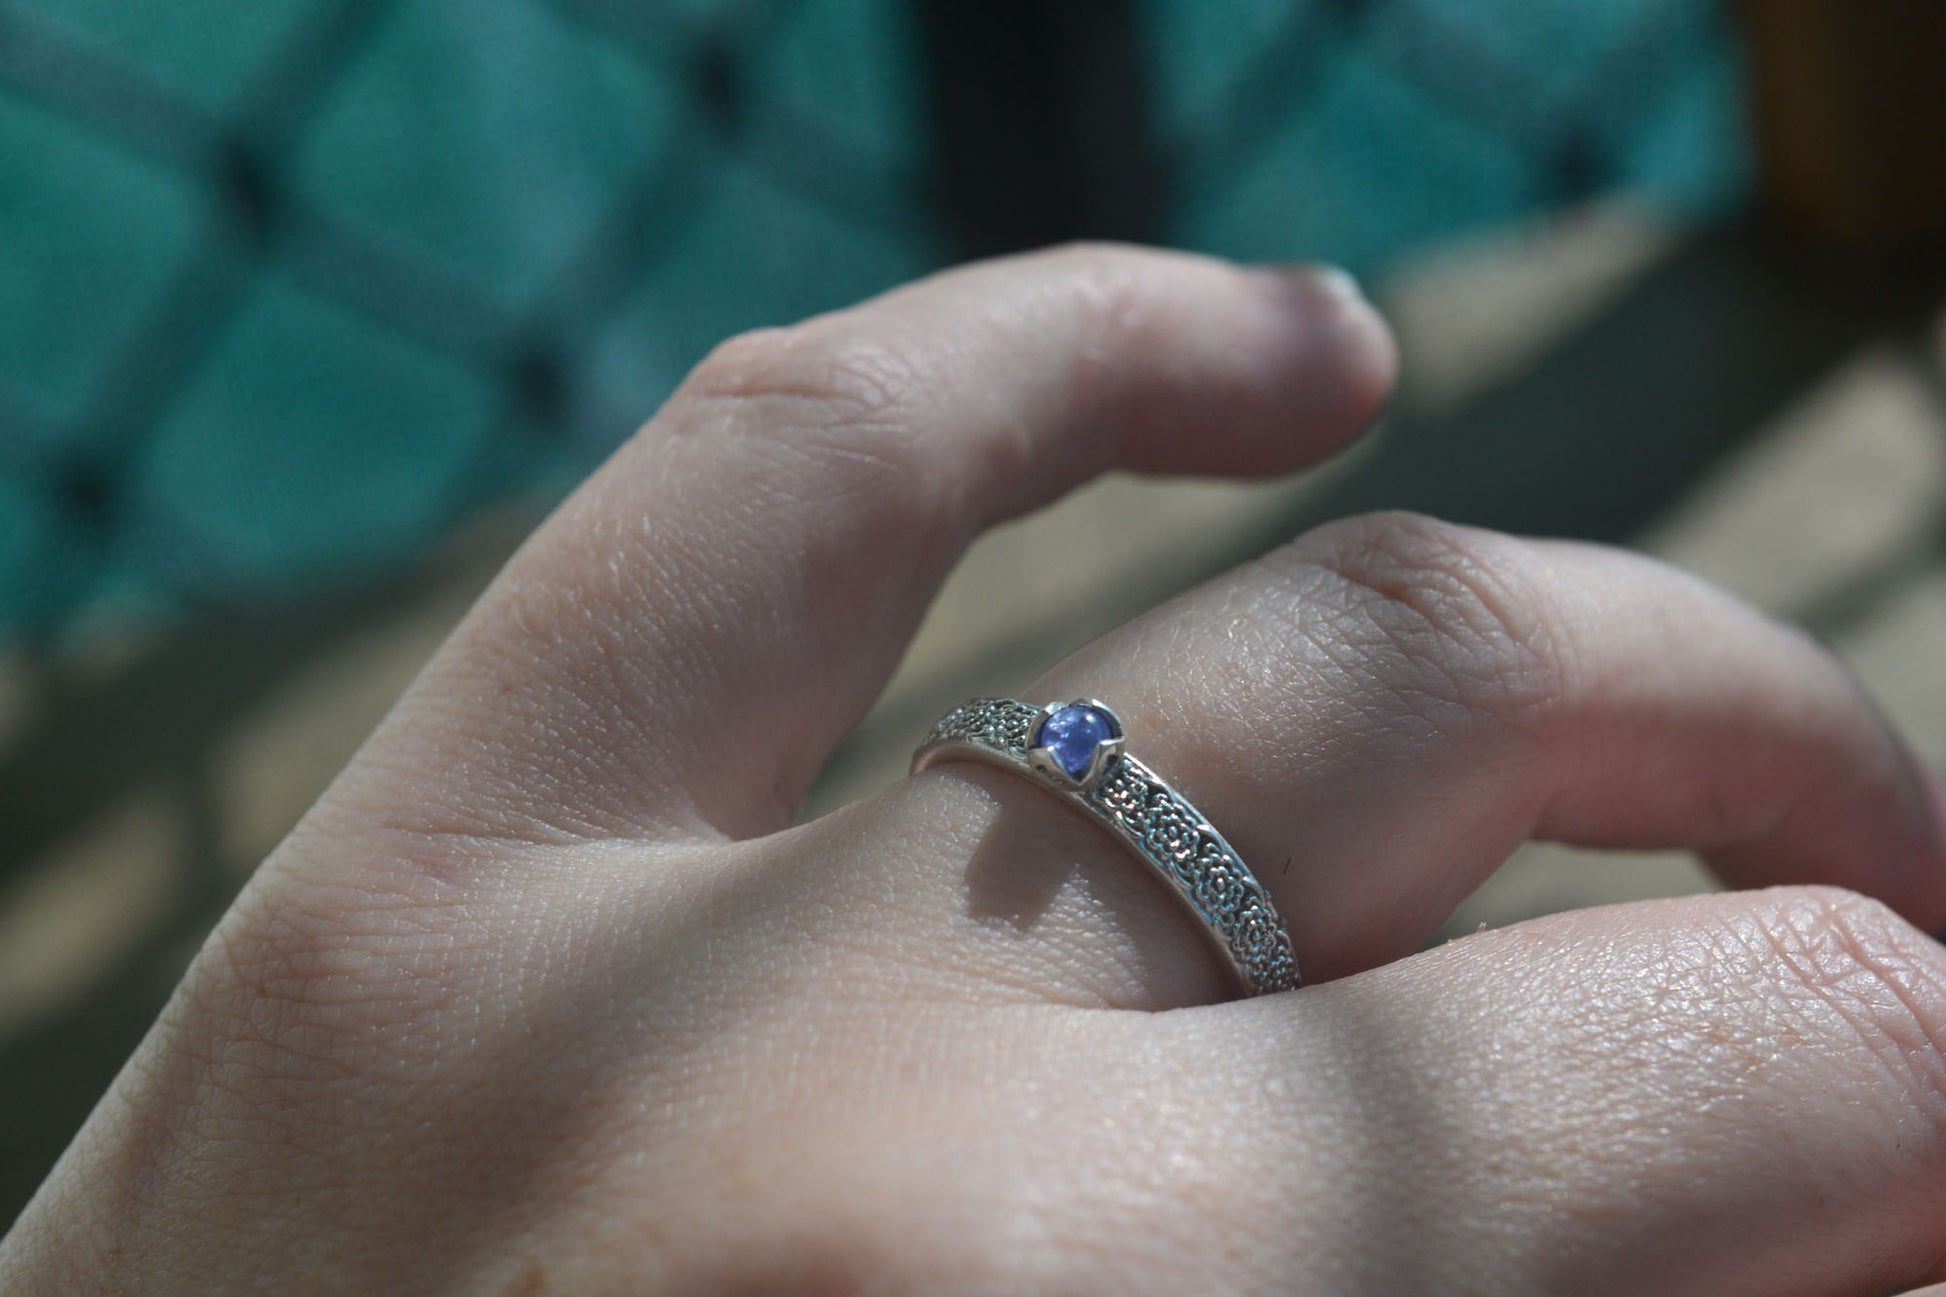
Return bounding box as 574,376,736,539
0,208,1946,1221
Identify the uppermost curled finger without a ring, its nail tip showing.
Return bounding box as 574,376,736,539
339,247,1391,837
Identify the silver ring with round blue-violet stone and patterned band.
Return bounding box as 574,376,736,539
913,697,1298,995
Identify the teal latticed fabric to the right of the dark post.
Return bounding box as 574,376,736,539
1142,0,1749,275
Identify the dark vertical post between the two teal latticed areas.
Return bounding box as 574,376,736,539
915,0,1168,257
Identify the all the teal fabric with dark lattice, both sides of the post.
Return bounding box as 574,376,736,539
0,0,1748,639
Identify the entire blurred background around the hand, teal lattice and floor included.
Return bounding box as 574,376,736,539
0,0,1946,1221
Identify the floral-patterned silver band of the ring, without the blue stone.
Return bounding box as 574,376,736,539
915,697,1298,995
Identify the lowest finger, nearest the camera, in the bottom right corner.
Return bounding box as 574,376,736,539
1128,888,1946,1297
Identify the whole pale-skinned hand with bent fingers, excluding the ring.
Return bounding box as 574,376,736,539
0,247,1946,1295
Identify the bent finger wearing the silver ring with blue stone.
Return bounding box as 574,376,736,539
871,516,1946,1003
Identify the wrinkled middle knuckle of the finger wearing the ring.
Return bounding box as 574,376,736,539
1273,512,1570,724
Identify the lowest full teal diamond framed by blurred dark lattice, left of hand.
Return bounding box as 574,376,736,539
124,271,502,590
